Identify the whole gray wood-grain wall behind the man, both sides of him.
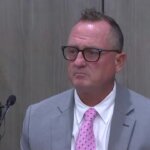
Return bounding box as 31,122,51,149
0,0,150,150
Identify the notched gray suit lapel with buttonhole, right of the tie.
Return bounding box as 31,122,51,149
108,85,135,150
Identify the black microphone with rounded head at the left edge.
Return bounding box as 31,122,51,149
0,95,16,126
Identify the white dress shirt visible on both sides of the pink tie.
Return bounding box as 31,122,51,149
71,83,116,150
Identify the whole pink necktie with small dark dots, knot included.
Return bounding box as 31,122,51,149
75,108,97,150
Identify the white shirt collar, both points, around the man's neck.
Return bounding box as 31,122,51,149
74,83,116,124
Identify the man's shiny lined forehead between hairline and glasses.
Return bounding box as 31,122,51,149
68,21,110,47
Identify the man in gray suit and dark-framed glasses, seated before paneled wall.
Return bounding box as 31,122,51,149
21,9,150,150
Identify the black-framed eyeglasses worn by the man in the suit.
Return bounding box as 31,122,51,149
62,46,121,62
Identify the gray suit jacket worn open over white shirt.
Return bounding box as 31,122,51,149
21,85,150,150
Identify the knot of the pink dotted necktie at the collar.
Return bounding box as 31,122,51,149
84,108,97,121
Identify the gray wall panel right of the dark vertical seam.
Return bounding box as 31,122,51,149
105,0,150,97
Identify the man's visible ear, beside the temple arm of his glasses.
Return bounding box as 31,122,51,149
115,52,127,73
